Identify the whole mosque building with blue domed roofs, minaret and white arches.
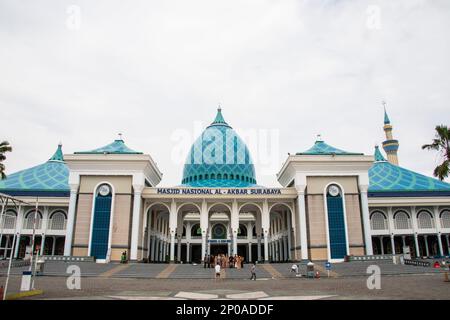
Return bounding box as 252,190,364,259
0,108,450,263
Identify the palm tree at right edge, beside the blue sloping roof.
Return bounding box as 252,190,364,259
422,125,450,181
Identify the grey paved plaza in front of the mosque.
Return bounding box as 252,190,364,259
0,261,450,300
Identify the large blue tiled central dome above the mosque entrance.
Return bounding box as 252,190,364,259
181,108,256,188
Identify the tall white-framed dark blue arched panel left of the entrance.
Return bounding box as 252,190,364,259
88,181,116,261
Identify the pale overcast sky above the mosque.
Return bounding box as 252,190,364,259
0,0,450,186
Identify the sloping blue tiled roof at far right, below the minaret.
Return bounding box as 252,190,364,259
369,147,450,196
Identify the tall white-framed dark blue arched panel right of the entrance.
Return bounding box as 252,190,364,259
323,182,349,261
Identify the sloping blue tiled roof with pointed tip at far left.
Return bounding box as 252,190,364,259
0,145,70,196
